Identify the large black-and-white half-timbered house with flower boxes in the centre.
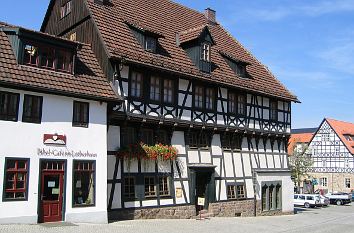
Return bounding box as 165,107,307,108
41,0,298,219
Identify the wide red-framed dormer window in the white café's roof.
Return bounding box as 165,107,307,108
23,42,73,72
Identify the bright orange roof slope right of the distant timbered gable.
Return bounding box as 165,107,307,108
325,118,354,155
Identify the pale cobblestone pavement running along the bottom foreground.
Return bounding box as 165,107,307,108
0,205,354,233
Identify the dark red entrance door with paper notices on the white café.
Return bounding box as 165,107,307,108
40,161,64,222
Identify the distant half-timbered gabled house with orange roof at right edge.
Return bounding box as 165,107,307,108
292,118,354,193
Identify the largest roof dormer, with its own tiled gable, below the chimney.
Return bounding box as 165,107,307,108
177,25,215,73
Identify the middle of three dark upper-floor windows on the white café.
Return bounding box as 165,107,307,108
22,95,43,123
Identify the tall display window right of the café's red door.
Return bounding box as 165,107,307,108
73,160,95,206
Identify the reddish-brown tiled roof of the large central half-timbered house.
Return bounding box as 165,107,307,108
87,0,298,101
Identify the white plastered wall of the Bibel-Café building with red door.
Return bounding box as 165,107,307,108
0,87,107,223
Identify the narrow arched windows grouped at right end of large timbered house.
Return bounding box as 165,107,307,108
261,182,281,211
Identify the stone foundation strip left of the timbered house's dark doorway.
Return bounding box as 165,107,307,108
108,205,196,220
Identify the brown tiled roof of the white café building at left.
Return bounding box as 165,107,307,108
0,22,121,101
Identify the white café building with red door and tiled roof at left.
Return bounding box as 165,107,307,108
0,22,120,224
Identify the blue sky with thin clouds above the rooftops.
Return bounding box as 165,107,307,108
0,0,354,128
